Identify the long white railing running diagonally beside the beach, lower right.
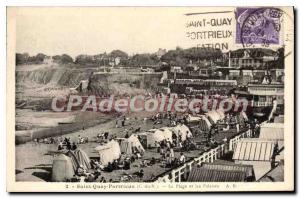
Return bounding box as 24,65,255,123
155,129,252,182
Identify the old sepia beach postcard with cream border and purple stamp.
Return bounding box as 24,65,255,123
7,7,295,192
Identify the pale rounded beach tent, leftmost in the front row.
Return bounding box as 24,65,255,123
51,154,75,182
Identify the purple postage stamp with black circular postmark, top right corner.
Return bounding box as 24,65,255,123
236,7,282,47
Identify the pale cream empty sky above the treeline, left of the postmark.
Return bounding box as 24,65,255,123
12,7,237,57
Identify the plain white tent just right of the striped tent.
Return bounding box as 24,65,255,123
95,140,121,166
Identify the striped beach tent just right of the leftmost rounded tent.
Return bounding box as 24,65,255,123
66,149,91,171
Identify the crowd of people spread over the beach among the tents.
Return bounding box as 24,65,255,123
37,107,259,182
